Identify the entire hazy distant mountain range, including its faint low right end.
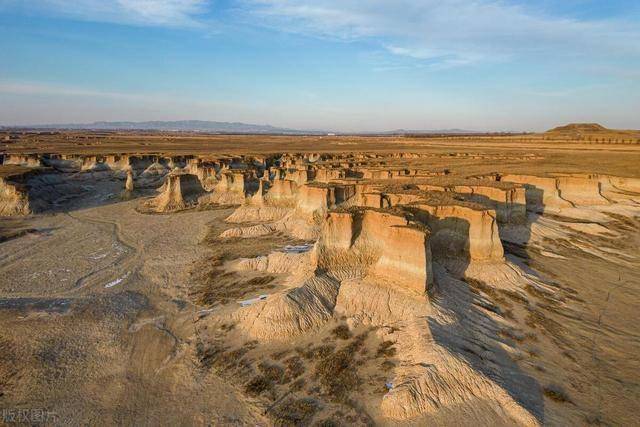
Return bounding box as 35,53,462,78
0,120,478,135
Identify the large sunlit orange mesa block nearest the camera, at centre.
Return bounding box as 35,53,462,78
318,209,433,294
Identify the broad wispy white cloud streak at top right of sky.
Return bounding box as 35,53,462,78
243,0,640,65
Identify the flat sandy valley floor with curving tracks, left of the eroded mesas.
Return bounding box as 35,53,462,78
0,197,268,425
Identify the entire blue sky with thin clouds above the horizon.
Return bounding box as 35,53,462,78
0,0,640,131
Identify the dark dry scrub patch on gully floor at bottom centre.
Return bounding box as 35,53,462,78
197,324,395,426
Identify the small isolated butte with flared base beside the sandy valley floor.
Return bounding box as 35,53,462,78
143,173,204,212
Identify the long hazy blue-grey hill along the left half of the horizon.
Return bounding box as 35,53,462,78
5,120,326,135
